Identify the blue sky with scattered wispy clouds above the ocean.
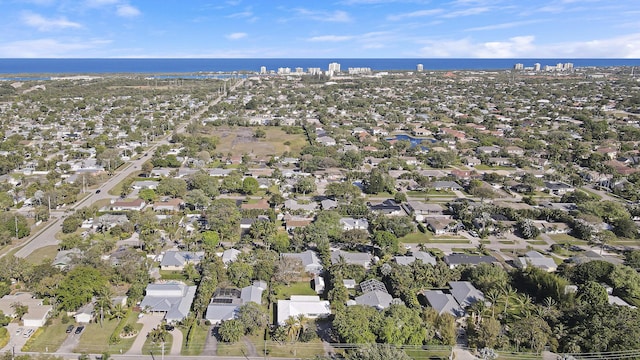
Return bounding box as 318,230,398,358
0,0,640,58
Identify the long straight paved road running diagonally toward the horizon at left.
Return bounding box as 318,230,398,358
15,79,244,258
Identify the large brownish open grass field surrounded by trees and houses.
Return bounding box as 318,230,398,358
212,126,307,157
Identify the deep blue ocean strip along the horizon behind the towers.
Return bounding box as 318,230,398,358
0,58,640,75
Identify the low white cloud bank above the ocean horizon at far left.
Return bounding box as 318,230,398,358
0,39,110,58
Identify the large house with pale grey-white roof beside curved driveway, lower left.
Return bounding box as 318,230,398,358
140,282,197,322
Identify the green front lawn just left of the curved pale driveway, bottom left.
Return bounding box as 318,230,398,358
75,311,142,354
